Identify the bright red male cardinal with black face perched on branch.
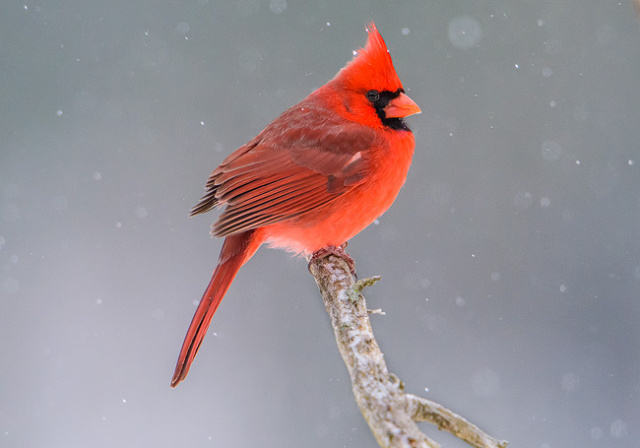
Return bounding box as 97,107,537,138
171,23,420,387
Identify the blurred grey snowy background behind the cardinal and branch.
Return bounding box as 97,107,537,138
0,0,640,448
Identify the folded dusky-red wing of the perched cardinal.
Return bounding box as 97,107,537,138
191,116,374,236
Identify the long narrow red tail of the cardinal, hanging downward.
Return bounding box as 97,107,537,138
171,229,264,387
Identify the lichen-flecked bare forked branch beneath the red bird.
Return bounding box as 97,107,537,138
309,255,507,448
